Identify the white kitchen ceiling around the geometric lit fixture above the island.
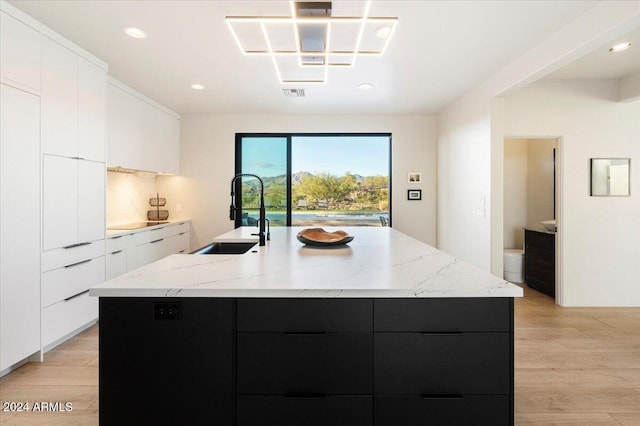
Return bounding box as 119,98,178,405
10,0,624,114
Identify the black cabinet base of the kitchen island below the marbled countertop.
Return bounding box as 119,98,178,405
100,298,514,426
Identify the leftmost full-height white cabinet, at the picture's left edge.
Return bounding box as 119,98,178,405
0,6,40,372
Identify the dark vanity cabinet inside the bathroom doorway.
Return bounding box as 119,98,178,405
524,229,556,297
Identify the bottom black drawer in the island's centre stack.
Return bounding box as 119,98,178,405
238,396,373,426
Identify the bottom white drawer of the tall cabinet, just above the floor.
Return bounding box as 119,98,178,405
42,292,98,346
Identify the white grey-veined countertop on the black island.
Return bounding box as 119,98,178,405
90,227,522,298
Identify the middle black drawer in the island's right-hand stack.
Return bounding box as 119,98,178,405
374,333,513,395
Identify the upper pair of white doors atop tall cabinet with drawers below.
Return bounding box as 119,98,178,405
41,37,107,162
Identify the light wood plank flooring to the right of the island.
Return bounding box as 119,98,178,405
515,287,640,426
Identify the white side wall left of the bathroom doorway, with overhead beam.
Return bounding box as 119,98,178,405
437,1,640,275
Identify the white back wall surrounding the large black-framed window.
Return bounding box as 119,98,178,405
157,115,436,248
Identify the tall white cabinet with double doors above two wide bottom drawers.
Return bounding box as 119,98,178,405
41,36,107,350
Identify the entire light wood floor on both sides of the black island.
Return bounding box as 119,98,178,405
0,288,640,426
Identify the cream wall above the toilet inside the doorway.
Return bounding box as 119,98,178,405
503,139,529,249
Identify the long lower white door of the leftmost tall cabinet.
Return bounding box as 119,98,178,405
0,82,40,371
